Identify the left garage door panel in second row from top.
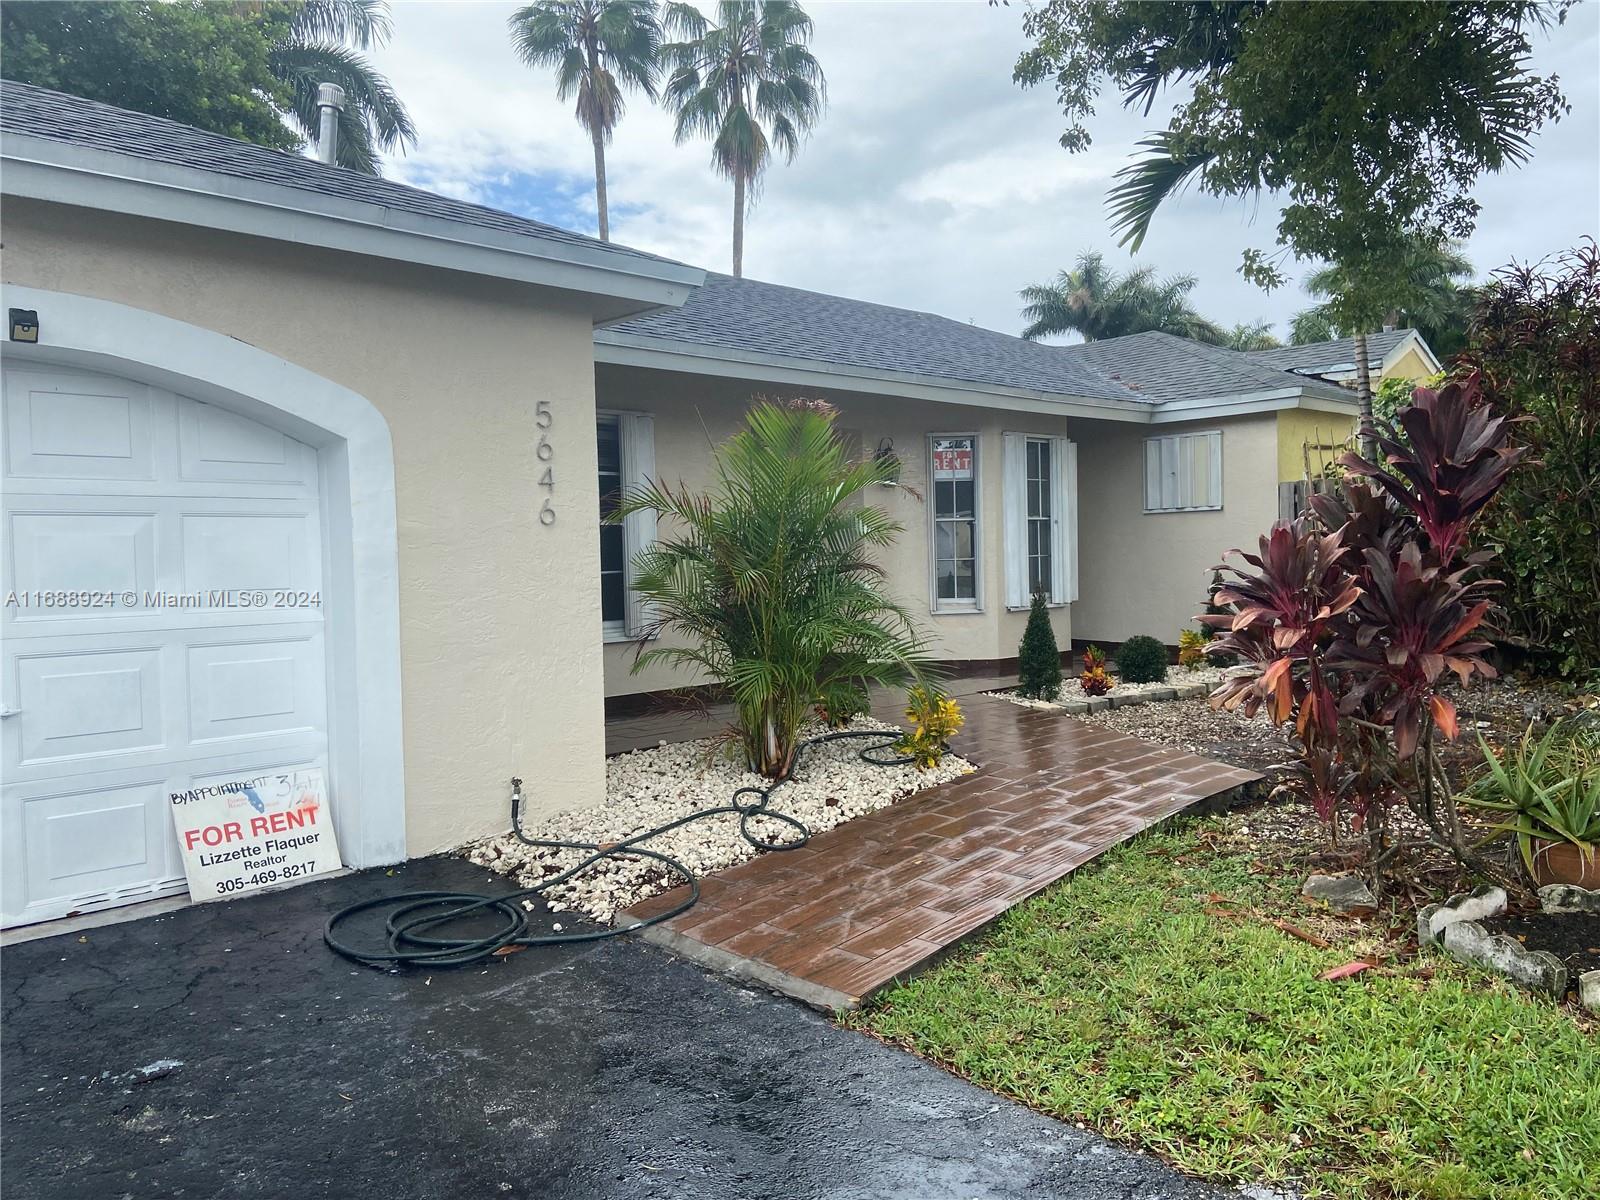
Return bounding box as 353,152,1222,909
6,507,157,604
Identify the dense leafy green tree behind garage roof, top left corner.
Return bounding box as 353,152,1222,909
0,0,301,150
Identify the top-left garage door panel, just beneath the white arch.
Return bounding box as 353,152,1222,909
5,371,155,480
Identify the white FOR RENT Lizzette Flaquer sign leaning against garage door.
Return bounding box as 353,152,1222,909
168,766,342,901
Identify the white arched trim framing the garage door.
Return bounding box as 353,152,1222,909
5,285,405,867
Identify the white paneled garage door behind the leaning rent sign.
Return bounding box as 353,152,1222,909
0,366,326,925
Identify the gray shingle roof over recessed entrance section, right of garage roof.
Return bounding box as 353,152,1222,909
597,275,1349,403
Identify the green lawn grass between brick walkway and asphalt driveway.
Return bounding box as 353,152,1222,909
848,822,1600,1200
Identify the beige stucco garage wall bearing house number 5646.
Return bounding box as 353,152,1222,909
0,198,605,854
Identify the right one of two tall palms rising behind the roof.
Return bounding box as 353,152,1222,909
662,0,827,277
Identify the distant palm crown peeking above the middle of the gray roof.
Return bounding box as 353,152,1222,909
1021,251,1227,344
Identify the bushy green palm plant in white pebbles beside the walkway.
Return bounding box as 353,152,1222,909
613,402,930,778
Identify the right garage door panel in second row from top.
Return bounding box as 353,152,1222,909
179,512,322,592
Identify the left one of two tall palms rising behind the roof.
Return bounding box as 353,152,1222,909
507,0,661,242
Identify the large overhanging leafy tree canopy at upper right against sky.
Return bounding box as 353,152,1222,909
1014,0,1574,328
